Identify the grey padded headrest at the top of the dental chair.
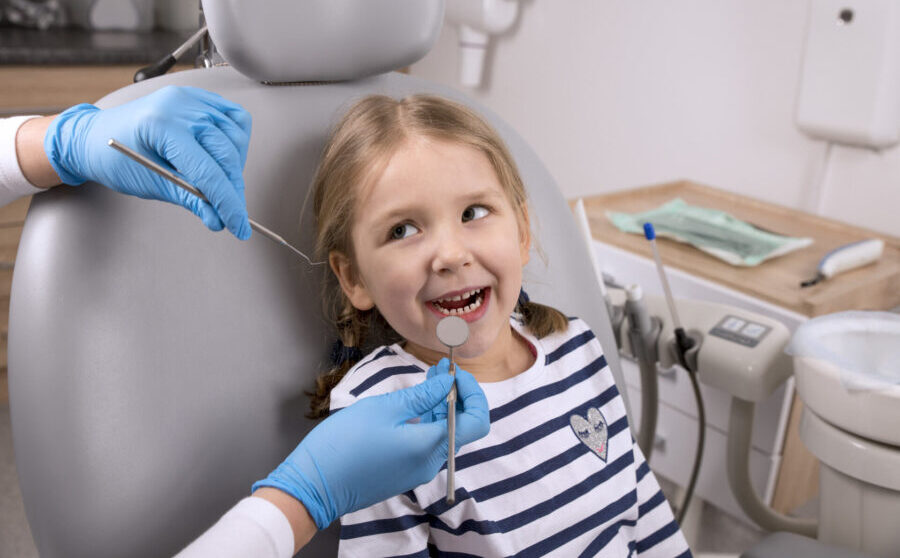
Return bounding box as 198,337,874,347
203,0,444,83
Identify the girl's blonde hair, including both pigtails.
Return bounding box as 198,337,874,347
309,95,568,418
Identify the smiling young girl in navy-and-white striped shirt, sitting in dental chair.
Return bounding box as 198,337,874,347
312,95,690,558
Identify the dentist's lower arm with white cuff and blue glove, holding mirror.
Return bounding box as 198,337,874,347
178,366,490,558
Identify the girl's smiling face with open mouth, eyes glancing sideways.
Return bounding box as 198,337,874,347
329,137,530,360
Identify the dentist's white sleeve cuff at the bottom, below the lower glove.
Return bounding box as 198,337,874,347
176,496,294,558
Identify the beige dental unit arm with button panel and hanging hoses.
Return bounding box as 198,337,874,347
612,294,818,537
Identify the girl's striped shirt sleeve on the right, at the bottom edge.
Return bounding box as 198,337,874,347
632,443,691,558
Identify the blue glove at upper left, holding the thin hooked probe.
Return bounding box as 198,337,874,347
44,86,251,240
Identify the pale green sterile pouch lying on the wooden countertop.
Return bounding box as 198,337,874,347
606,198,813,266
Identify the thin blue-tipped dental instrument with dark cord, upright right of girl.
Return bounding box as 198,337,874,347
644,222,706,524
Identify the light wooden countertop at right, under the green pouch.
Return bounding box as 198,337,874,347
584,181,900,317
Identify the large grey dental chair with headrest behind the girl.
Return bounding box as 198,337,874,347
9,0,624,558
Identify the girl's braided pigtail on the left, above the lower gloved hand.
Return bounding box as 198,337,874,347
306,297,372,419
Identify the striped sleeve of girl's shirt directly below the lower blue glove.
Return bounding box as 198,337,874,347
338,491,430,558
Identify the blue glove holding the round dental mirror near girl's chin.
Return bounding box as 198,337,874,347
253,359,491,529
